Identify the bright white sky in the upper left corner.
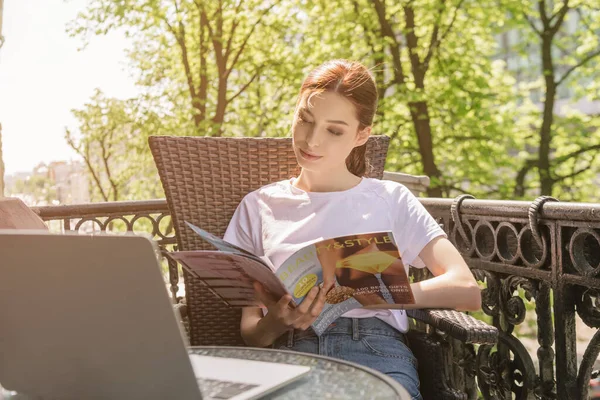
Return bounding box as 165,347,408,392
0,0,136,175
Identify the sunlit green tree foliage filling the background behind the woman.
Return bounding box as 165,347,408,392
67,0,600,201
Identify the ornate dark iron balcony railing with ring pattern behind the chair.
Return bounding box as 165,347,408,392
35,196,600,400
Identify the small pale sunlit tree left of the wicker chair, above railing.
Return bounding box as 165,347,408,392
65,90,161,201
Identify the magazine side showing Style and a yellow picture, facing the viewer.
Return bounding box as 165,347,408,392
277,232,414,335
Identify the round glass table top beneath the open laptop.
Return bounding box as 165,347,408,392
189,346,411,400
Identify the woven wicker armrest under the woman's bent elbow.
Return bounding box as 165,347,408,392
406,309,498,344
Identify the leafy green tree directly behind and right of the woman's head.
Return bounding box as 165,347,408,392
306,0,517,197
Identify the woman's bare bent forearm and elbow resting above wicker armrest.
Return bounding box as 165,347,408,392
406,237,481,311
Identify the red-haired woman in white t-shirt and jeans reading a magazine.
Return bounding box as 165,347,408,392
225,60,481,399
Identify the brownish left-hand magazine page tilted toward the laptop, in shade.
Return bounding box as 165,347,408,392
168,251,287,307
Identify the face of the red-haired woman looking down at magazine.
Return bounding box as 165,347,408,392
292,92,370,171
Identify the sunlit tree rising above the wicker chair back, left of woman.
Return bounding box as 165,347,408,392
70,0,304,136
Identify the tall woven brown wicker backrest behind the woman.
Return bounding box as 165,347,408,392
149,136,389,345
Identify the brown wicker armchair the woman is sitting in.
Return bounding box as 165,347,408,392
149,136,498,399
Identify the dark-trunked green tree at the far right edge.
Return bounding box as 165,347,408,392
508,0,600,200
